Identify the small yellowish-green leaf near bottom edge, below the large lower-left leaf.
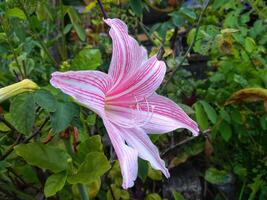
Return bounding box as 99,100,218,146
44,171,67,197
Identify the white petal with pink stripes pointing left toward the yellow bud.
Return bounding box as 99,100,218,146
50,71,113,116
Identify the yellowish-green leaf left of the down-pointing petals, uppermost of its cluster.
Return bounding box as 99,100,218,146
75,135,103,162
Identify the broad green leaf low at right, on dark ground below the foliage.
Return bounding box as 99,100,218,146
204,168,232,184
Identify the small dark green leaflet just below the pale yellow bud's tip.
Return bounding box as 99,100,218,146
34,89,57,112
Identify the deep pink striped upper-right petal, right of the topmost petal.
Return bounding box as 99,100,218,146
106,56,166,104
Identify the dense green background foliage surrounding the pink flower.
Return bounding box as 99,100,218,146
0,0,267,200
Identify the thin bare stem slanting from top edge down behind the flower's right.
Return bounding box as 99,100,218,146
161,0,209,92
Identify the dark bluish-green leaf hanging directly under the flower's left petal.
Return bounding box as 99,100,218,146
51,102,80,133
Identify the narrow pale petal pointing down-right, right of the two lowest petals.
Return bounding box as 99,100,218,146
122,127,170,178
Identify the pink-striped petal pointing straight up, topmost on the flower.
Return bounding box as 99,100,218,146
104,19,147,87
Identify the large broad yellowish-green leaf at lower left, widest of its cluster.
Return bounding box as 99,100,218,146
14,143,69,173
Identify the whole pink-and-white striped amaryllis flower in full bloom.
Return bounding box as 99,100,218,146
50,19,199,189
